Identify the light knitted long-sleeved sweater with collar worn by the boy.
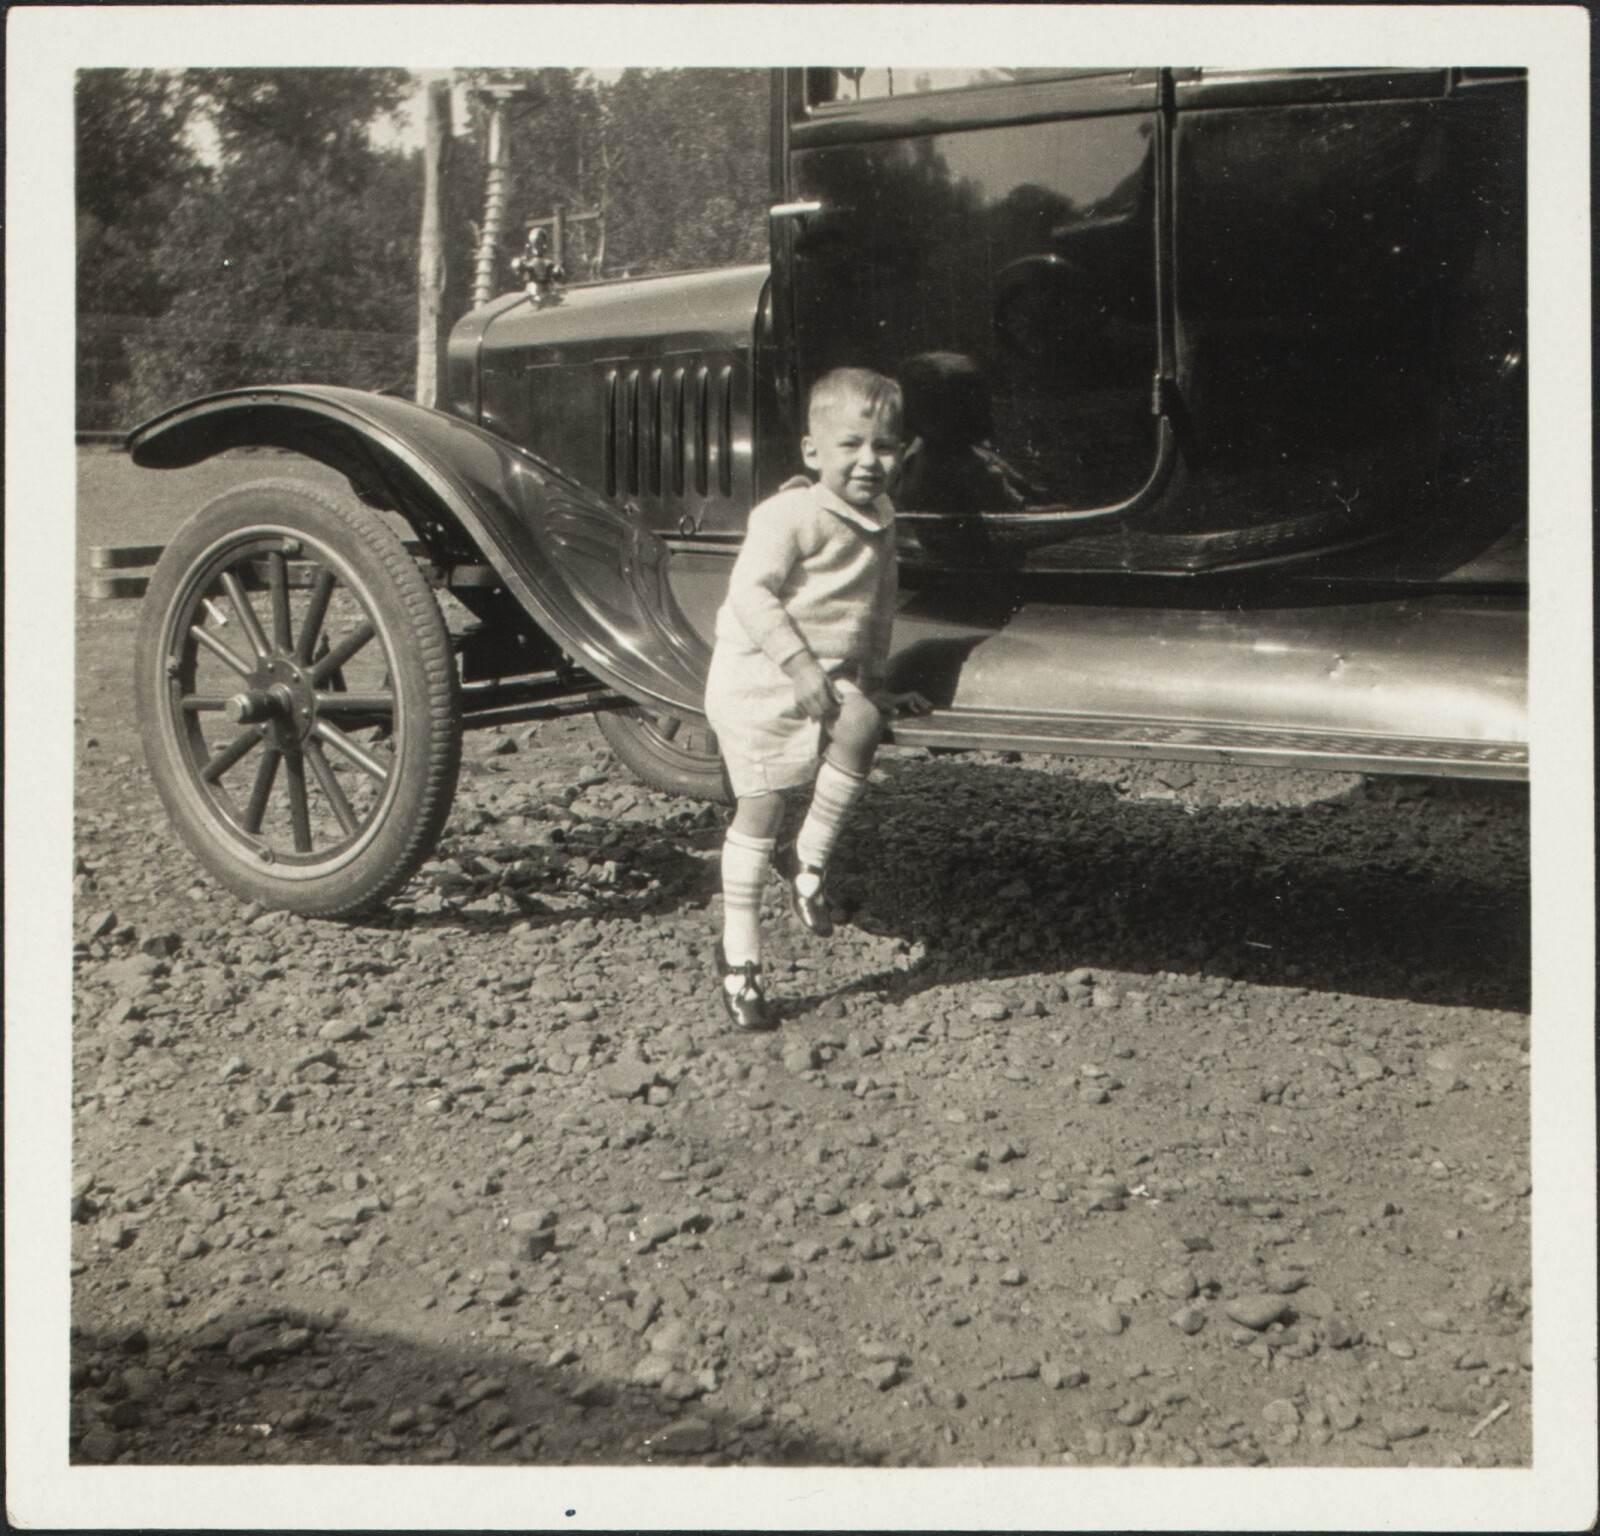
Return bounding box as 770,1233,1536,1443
717,482,899,682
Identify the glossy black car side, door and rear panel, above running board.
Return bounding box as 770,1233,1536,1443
774,58,1526,579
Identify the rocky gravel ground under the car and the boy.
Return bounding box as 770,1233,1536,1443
72,456,1531,1466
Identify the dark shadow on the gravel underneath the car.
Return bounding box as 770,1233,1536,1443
376,760,1531,1011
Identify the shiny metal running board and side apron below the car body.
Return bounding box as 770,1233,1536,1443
890,592,1528,779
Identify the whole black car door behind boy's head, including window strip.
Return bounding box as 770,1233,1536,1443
773,69,1170,563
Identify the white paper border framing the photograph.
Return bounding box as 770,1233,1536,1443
5,5,1597,1531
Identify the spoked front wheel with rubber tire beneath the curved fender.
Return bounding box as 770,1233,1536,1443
134,480,461,918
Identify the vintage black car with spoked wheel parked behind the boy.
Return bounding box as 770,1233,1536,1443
130,69,1528,915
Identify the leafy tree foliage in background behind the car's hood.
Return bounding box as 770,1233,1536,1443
77,69,766,426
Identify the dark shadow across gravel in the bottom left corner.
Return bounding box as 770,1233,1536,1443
70,1306,883,1466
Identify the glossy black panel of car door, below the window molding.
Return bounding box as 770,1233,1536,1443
787,90,1160,512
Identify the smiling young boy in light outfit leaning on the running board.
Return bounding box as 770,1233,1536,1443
706,368,933,1029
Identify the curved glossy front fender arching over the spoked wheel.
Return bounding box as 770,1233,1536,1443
128,384,710,717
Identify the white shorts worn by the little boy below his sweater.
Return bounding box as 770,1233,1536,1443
706,645,861,800
